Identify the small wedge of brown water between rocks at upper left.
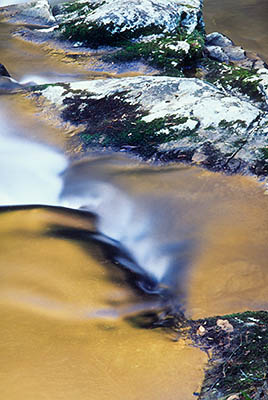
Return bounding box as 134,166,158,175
0,19,109,84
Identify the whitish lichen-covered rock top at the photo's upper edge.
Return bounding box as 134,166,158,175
56,0,203,47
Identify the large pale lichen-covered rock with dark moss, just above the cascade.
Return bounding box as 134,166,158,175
30,77,268,175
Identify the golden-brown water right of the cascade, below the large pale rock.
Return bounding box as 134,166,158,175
60,156,268,318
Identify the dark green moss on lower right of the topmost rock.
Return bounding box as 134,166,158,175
106,30,204,76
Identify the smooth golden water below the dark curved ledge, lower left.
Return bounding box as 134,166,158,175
0,209,206,400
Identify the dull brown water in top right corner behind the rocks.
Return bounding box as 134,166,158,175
204,0,268,62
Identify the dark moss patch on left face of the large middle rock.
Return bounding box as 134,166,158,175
62,93,193,158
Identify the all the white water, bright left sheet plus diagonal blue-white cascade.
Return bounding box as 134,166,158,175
0,106,188,283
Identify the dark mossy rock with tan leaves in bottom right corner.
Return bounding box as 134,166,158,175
190,311,268,400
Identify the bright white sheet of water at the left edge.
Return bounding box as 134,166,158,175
0,114,67,205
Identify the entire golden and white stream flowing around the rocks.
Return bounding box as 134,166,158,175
0,0,268,400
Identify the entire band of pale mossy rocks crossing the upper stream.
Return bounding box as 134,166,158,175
2,0,268,177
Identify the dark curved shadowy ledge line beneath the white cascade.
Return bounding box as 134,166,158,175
0,205,186,327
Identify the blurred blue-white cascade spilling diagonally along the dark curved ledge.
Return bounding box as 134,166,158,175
61,177,172,282
